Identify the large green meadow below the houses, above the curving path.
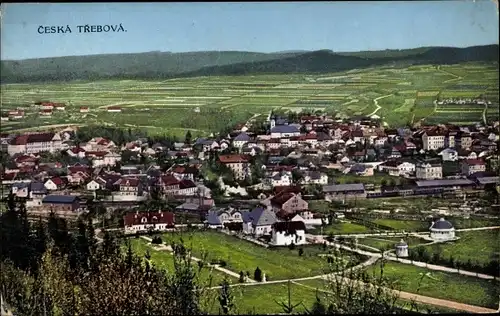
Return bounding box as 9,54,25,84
163,231,357,280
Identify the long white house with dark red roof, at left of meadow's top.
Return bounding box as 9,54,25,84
123,211,175,234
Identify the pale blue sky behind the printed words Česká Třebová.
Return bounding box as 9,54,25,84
0,0,499,60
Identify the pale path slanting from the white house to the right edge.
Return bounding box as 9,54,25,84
306,234,499,280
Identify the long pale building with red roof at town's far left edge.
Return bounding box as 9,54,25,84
7,133,63,156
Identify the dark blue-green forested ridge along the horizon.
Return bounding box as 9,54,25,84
0,45,499,83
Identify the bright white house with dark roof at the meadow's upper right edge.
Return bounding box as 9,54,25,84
271,221,306,246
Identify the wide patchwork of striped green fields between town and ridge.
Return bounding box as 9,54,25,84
1,64,498,136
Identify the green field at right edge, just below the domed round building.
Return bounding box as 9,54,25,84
426,229,500,264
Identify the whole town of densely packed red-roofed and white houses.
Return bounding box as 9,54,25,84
2,108,500,311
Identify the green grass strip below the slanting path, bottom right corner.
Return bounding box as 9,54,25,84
367,262,500,309
